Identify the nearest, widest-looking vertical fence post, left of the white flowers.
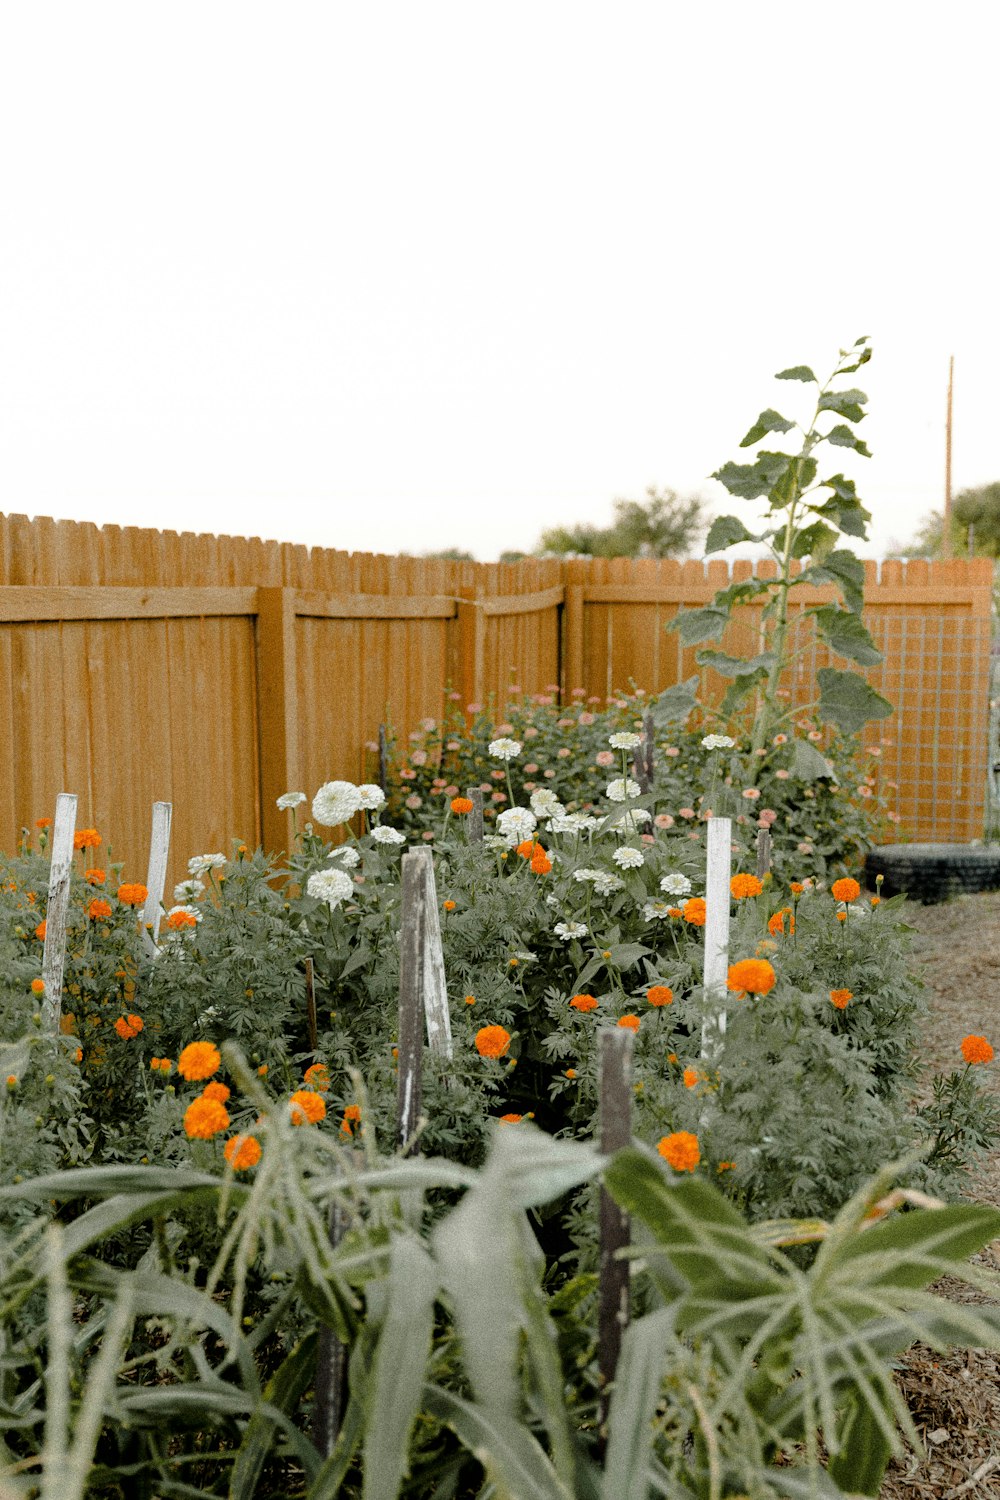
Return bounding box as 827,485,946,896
256,588,298,854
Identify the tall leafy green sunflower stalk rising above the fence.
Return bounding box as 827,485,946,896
667,338,892,776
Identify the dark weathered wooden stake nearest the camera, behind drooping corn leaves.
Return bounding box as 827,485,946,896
597,1028,634,1443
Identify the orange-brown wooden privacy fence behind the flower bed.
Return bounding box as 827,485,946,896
0,516,993,878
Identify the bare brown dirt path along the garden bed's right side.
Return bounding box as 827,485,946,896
882,891,1000,1500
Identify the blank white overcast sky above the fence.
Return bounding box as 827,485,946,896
0,0,1000,558
